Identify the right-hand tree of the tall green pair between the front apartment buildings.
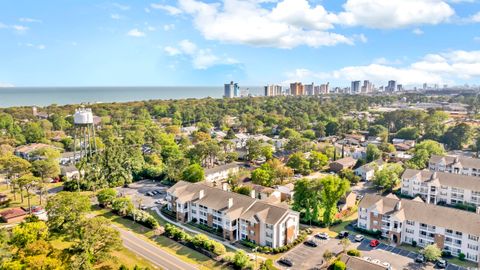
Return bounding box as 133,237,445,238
320,175,350,225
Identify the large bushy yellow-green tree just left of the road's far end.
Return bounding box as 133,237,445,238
45,191,90,236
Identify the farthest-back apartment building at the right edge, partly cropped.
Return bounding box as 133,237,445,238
428,155,480,176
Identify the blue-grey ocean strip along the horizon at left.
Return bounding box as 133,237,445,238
0,86,262,108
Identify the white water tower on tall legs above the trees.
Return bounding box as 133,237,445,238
73,107,97,162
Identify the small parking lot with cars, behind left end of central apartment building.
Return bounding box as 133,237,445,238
117,180,168,208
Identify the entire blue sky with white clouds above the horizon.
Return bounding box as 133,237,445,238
0,0,480,87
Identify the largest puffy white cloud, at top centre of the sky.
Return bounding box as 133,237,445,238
178,0,353,48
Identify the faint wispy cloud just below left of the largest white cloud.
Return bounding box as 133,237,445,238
164,40,238,69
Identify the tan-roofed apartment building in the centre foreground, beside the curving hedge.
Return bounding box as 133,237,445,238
167,181,300,248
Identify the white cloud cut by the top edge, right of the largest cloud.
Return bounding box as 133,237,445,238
337,0,455,29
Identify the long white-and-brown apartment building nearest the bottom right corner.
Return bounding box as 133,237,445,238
357,194,480,262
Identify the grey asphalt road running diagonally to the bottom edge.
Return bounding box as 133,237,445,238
115,227,198,270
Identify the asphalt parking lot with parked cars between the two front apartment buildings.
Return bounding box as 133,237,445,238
277,235,466,270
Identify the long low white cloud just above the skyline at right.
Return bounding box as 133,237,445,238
286,50,480,85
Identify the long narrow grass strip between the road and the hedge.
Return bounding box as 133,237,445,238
93,207,230,269
